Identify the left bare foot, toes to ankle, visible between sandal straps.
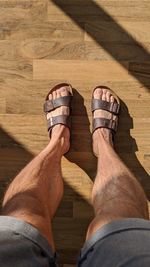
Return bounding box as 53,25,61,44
47,86,70,154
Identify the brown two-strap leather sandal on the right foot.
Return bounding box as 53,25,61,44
91,86,120,134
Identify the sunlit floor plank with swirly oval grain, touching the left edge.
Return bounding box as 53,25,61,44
0,37,85,60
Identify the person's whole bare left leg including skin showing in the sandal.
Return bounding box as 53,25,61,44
2,88,70,251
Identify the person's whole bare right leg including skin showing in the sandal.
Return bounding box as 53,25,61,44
86,89,149,239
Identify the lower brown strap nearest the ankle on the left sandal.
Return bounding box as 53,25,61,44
47,115,71,132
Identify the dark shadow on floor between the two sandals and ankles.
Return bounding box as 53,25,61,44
65,88,97,181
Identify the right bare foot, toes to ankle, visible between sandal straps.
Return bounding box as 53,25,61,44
93,88,116,155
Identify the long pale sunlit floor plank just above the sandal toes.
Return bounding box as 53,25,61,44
33,59,133,81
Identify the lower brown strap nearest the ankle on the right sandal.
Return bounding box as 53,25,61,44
93,118,118,133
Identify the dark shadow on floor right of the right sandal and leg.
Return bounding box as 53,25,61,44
115,100,150,200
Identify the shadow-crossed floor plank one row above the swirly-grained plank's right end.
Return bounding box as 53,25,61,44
85,21,150,44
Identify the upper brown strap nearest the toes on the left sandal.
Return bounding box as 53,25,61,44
44,95,72,113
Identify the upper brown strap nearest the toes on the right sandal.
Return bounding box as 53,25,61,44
92,98,120,115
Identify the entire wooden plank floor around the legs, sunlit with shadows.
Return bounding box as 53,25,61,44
0,0,150,267
